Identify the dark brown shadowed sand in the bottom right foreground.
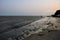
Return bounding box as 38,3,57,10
24,30,60,40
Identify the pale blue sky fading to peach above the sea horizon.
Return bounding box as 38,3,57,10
0,0,60,16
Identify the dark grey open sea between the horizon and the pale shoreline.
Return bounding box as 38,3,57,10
0,16,41,32
